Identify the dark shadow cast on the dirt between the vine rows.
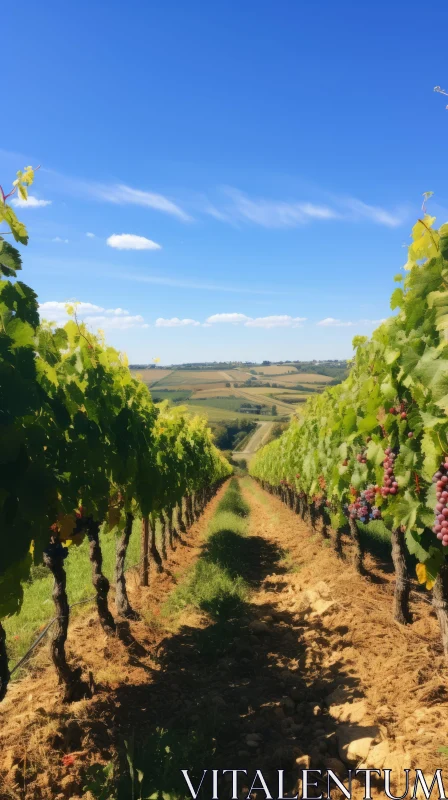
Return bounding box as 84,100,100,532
79,530,361,800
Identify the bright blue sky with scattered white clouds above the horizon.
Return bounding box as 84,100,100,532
0,0,448,363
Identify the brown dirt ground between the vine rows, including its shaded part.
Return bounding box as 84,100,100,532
0,478,448,800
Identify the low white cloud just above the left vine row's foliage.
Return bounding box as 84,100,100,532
39,300,149,330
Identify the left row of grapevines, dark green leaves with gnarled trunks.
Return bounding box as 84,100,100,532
0,167,231,699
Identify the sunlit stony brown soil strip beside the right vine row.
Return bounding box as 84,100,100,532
245,481,448,788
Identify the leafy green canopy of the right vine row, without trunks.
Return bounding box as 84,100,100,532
250,215,448,576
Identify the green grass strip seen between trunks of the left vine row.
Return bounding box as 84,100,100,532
2,520,145,667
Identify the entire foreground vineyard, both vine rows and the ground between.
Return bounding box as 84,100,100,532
0,167,448,800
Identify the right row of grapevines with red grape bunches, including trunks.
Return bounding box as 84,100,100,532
251,206,448,655
